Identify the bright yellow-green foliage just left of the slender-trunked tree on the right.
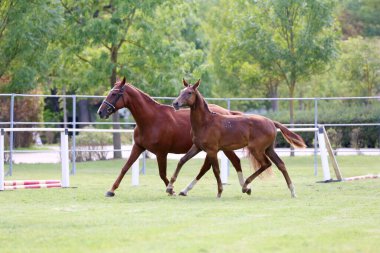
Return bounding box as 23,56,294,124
200,0,273,109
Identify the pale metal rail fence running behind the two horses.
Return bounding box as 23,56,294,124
0,94,380,178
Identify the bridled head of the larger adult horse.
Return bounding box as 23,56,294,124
98,77,127,119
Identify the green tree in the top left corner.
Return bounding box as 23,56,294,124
0,0,62,93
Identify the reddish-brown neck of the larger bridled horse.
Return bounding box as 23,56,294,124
125,85,159,127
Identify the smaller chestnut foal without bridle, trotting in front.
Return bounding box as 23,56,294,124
167,80,306,197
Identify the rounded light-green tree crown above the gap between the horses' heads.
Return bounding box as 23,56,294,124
120,1,208,96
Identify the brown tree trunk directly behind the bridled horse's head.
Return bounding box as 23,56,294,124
110,45,121,159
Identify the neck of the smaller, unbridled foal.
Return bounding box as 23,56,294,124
190,93,212,132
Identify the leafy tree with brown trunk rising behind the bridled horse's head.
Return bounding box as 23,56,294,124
61,0,165,158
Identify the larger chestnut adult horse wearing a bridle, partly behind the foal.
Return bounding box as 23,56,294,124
98,77,250,197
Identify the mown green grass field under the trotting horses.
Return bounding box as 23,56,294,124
0,156,380,253
